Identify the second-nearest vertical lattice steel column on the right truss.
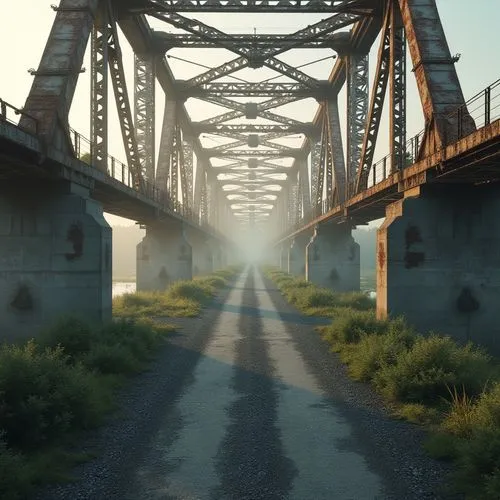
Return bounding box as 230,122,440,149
346,54,368,189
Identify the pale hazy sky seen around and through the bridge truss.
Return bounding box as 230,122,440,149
0,0,500,225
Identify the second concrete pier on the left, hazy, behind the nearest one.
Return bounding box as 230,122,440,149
136,221,193,290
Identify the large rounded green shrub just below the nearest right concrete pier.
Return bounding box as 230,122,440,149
374,334,492,404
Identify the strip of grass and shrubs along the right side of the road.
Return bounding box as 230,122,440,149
265,269,500,500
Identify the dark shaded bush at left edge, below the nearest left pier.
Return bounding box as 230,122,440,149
0,341,110,449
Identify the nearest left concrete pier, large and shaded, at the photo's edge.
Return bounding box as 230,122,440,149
0,181,112,340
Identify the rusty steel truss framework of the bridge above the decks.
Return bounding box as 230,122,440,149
24,0,475,234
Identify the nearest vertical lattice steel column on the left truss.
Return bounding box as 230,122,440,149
90,4,109,172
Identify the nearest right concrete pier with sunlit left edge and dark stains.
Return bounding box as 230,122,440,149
377,184,500,354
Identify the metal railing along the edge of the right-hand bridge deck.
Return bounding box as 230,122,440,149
286,79,500,233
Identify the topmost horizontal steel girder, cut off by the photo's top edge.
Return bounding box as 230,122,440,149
143,0,373,14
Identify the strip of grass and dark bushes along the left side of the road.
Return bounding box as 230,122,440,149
0,268,242,500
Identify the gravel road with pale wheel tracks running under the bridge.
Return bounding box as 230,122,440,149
36,267,458,500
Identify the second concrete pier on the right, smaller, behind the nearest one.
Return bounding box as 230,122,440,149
306,224,360,292
